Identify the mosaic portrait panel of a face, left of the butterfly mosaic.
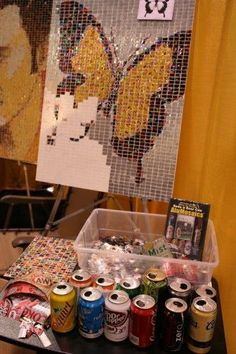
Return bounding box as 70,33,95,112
0,0,52,163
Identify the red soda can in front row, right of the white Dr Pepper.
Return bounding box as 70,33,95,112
129,294,156,348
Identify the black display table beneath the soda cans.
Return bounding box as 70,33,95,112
0,280,227,354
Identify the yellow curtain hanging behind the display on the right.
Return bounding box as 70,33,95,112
174,0,236,354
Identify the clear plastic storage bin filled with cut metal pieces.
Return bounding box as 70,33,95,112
75,209,219,284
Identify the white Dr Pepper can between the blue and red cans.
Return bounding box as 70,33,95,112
104,290,131,342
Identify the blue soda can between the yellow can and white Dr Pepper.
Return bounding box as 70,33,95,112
78,287,104,338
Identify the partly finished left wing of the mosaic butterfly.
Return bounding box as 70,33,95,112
57,1,114,104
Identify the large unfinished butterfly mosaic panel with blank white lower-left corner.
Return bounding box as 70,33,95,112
37,0,195,201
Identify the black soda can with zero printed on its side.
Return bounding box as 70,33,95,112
160,297,188,351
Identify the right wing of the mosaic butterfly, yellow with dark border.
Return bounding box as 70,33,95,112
112,31,191,182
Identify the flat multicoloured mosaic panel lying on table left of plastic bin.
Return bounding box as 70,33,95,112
4,235,77,283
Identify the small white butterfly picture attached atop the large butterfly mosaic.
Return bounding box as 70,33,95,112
138,0,175,21
